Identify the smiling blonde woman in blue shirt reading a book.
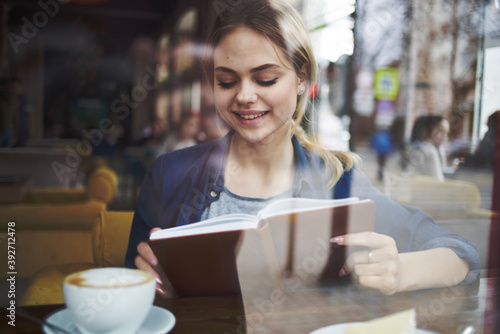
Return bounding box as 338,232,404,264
126,0,479,295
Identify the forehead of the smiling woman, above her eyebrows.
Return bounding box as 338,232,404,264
214,27,292,70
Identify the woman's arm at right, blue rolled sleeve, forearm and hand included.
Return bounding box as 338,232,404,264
340,171,480,294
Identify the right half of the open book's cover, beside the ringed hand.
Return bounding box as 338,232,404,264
268,200,375,290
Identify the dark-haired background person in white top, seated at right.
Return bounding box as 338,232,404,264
402,115,450,181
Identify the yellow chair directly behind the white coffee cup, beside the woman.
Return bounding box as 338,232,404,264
19,211,134,305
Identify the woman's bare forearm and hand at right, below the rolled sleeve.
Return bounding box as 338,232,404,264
332,232,469,295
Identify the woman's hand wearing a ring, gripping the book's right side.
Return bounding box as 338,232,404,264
331,232,402,295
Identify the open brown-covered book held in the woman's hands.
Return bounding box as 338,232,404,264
149,197,375,296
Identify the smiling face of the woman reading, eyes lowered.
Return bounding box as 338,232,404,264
214,28,303,143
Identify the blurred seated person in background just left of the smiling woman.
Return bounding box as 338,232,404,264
157,112,201,157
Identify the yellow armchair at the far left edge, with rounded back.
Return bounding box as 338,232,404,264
0,166,118,279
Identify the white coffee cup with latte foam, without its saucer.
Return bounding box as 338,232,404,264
63,268,156,334
